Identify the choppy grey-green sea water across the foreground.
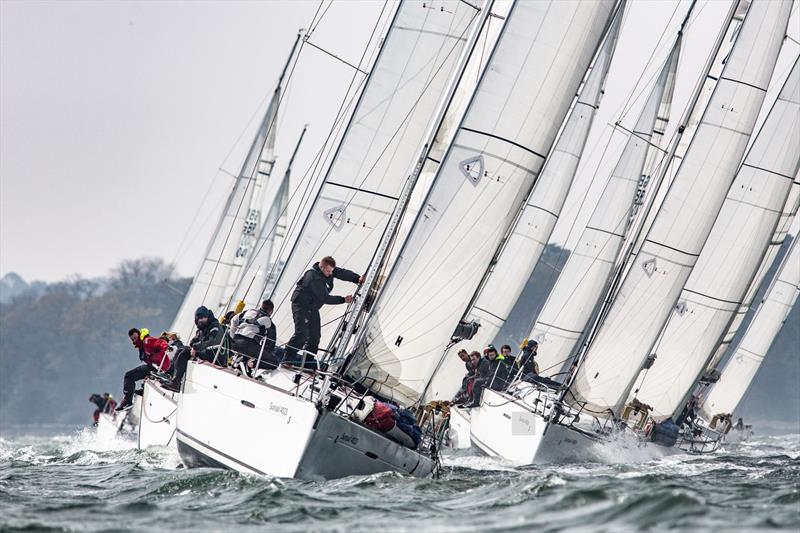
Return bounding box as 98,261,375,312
0,430,800,532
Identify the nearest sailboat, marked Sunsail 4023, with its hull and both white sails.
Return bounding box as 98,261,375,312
173,1,614,479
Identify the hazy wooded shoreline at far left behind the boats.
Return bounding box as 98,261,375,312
0,259,191,425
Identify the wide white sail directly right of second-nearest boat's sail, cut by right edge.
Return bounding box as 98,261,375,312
634,56,800,419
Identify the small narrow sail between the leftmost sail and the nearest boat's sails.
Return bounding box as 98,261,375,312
231,126,308,308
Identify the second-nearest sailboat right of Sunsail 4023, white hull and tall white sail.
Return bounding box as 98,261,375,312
446,2,790,462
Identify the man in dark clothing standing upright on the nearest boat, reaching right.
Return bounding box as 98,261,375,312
286,256,364,362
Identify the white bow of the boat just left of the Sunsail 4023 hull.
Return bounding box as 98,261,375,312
139,379,178,450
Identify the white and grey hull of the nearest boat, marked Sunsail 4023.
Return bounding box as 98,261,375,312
177,362,433,479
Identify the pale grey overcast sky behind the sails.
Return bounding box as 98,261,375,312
0,0,800,280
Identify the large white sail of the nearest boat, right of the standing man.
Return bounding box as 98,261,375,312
350,0,613,404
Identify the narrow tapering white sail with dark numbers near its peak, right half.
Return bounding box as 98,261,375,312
529,36,682,375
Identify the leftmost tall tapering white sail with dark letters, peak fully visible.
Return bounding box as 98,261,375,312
170,34,301,338
